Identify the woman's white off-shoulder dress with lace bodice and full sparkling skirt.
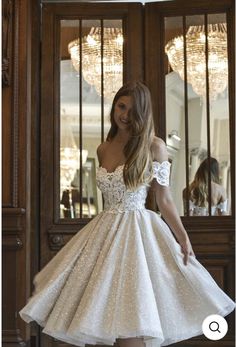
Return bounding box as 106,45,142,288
19,161,236,347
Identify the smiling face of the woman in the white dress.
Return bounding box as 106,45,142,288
114,96,133,129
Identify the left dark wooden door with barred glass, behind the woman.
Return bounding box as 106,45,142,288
40,3,143,347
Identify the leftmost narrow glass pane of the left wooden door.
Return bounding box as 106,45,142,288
60,20,80,218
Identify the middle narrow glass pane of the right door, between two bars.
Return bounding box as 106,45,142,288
185,15,208,216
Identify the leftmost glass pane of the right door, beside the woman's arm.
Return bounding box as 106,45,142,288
165,17,186,215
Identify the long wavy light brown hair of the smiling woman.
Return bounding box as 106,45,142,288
106,81,154,190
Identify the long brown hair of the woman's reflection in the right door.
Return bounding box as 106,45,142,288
189,157,220,207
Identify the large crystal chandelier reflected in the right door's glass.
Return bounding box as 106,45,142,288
165,23,228,100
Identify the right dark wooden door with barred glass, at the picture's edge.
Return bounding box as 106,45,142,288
145,0,235,347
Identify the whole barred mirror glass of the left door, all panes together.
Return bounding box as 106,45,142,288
58,20,123,218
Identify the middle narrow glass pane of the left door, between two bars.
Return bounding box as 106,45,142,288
80,20,102,218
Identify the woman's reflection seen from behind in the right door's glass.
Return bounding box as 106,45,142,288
183,158,227,216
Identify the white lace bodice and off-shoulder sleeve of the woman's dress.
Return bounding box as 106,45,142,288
96,161,171,213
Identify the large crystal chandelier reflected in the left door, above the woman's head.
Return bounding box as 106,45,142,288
68,27,123,100
